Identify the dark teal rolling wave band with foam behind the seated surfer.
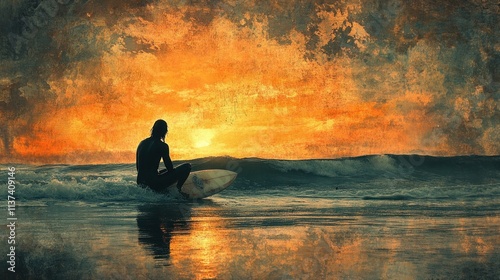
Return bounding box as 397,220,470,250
4,155,500,202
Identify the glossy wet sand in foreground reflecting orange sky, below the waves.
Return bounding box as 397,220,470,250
2,196,500,279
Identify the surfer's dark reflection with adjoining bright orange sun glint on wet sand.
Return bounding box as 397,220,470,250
137,200,231,279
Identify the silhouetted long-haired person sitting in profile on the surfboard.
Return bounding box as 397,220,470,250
136,119,191,197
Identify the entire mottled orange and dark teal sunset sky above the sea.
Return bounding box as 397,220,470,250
0,0,500,163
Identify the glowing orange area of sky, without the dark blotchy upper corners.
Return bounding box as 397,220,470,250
1,1,498,162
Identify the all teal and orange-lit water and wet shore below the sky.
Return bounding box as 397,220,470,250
0,155,500,279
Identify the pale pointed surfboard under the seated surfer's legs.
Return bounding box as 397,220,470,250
168,169,238,199
